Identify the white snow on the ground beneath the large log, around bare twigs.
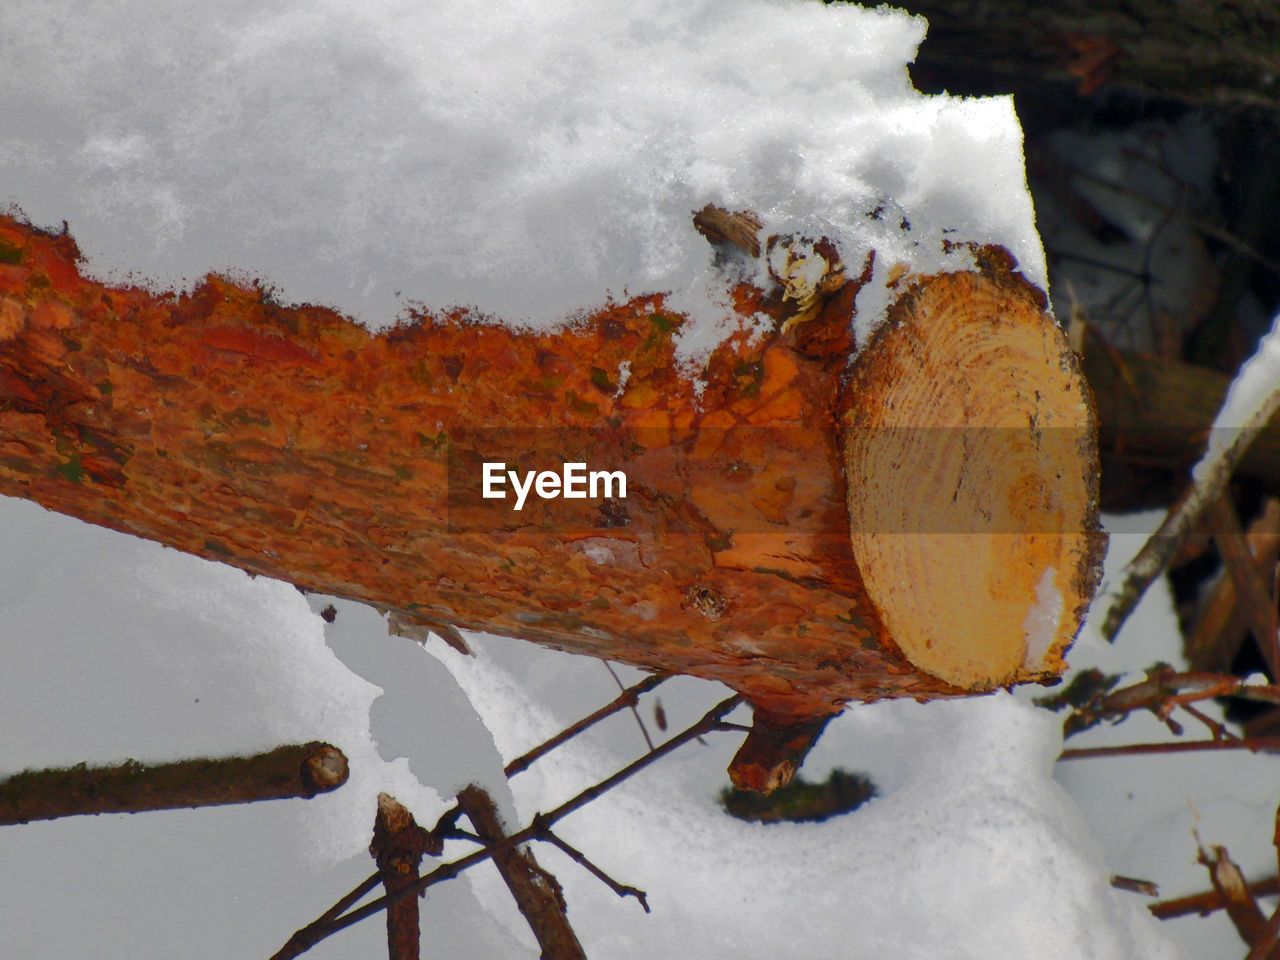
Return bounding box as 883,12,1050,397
0,498,1178,960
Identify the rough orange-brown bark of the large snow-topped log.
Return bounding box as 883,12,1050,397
0,219,1096,788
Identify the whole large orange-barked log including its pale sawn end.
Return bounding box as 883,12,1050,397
0,219,1100,785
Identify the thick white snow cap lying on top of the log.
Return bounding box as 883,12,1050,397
0,0,1044,357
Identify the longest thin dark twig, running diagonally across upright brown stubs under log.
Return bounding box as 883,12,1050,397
271,695,742,960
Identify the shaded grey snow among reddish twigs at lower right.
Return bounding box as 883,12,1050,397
1039,511,1280,957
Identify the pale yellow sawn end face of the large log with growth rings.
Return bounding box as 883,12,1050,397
845,261,1102,690
